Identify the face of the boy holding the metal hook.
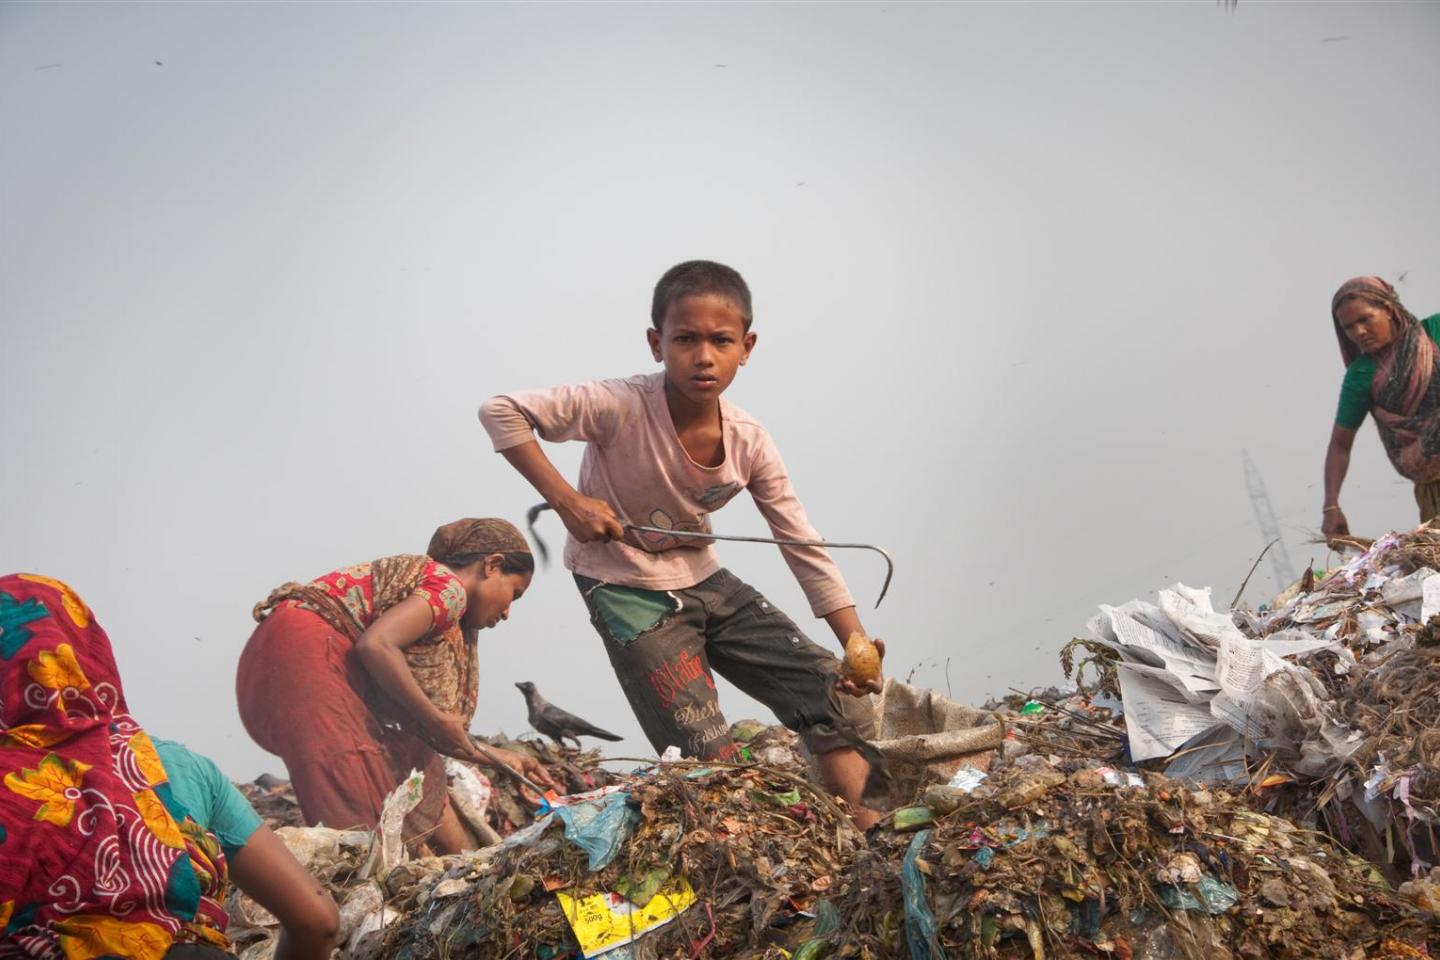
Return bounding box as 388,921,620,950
645,294,755,403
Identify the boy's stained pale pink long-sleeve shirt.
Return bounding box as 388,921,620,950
480,373,854,616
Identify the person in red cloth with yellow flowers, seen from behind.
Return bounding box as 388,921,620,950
0,574,338,960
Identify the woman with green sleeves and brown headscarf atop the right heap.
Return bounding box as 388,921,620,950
1320,276,1440,537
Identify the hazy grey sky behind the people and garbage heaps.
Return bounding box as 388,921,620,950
0,0,1440,777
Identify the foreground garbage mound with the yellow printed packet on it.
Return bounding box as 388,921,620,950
377,730,864,960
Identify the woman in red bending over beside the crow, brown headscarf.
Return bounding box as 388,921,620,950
236,520,554,853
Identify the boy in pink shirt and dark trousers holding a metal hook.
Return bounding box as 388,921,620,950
480,261,883,829
